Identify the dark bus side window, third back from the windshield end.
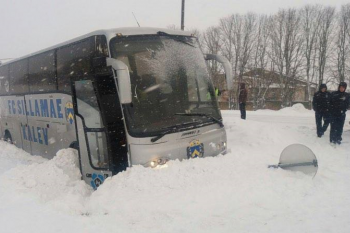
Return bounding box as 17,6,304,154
9,59,29,94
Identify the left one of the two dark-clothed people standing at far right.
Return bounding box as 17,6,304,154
312,84,331,138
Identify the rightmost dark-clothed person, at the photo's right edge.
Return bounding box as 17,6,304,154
330,82,350,145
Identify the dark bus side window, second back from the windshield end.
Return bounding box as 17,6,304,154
29,51,56,92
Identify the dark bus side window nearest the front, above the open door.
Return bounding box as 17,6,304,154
57,38,94,93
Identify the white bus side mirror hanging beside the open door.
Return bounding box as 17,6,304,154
107,58,132,104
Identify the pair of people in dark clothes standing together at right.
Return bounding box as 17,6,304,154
312,82,350,145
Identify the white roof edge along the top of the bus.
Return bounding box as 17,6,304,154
0,27,192,67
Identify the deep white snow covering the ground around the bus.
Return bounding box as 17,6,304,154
0,106,350,233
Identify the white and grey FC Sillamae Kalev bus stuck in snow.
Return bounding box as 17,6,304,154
0,28,232,189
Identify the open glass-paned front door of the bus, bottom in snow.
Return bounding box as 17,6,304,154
73,80,112,189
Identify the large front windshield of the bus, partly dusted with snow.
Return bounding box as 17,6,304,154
111,36,221,136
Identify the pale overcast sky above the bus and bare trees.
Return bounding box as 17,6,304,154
0,0,349,59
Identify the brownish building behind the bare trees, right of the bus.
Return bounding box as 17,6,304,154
213,69,317,110
